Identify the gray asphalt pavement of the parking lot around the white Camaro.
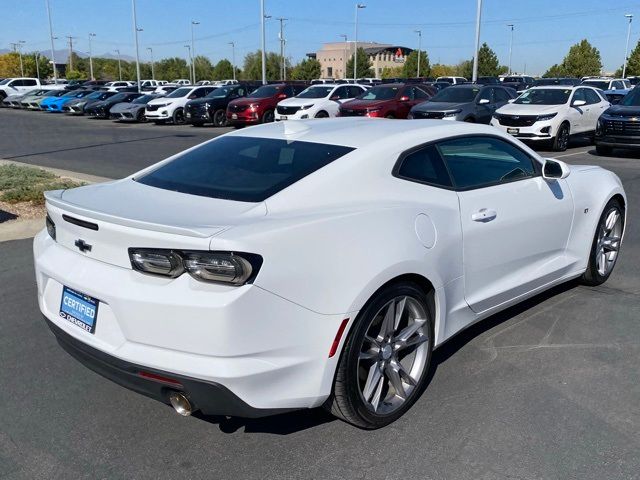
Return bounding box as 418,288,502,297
0,110,640,480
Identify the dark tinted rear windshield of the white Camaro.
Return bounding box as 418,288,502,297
135,136,353,202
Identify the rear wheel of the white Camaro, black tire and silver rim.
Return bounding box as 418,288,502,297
326,283,434,429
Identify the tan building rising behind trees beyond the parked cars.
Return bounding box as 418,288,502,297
316,42,413,78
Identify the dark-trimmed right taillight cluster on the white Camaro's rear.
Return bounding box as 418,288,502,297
129,248,262,285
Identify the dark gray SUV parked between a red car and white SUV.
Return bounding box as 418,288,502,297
407,84,517,125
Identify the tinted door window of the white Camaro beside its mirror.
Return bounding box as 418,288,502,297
437,137,536,190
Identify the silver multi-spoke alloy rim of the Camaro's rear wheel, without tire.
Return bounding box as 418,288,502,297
358,296,429,415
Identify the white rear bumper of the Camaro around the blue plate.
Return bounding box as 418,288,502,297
34,230,345,414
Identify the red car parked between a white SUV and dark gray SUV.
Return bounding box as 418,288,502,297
339,83,432,118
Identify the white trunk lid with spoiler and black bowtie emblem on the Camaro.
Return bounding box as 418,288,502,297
45,178,266,268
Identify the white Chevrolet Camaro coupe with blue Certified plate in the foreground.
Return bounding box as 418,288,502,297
34,118,626,428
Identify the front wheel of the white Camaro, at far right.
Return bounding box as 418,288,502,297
581,199,624,285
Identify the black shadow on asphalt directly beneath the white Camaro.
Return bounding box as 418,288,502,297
193,280,579,435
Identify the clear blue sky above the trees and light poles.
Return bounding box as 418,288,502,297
0,0,640,74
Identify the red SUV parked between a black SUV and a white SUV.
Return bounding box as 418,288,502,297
227,83,307,127
